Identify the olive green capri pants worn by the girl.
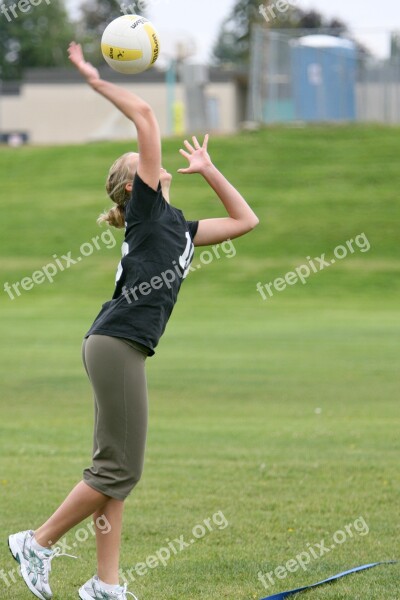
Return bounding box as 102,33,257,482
82,335,148,500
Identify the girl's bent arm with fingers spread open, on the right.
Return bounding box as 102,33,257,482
178,135,259,246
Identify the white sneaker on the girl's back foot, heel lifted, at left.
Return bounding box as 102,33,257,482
8,529,77,600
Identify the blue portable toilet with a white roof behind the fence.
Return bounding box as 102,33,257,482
291,35,357,121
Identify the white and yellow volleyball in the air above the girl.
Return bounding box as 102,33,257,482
101,15,160,75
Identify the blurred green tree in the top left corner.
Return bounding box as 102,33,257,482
0,0,74,80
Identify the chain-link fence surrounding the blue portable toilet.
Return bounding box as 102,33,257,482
247,26,400,124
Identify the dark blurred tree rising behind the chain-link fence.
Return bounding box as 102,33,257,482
212,0,347,66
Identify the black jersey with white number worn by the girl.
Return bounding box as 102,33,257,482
84,174,199,356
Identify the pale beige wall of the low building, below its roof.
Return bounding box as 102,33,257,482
0,79,239,144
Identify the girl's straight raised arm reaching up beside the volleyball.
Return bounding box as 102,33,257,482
68,42,161,190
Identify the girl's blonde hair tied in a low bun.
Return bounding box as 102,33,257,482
97,152,138,229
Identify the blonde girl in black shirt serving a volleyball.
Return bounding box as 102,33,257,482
9,42,258,600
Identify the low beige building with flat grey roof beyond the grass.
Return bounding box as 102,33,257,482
0,67,246,144
